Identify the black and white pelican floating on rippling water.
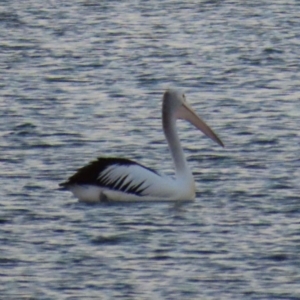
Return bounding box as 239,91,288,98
60,90,224,202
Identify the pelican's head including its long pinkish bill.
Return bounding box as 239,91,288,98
163,90,224,147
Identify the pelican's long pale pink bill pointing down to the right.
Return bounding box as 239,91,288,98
176,102,224,147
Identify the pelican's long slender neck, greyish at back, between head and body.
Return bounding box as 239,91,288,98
162,108,192,177
